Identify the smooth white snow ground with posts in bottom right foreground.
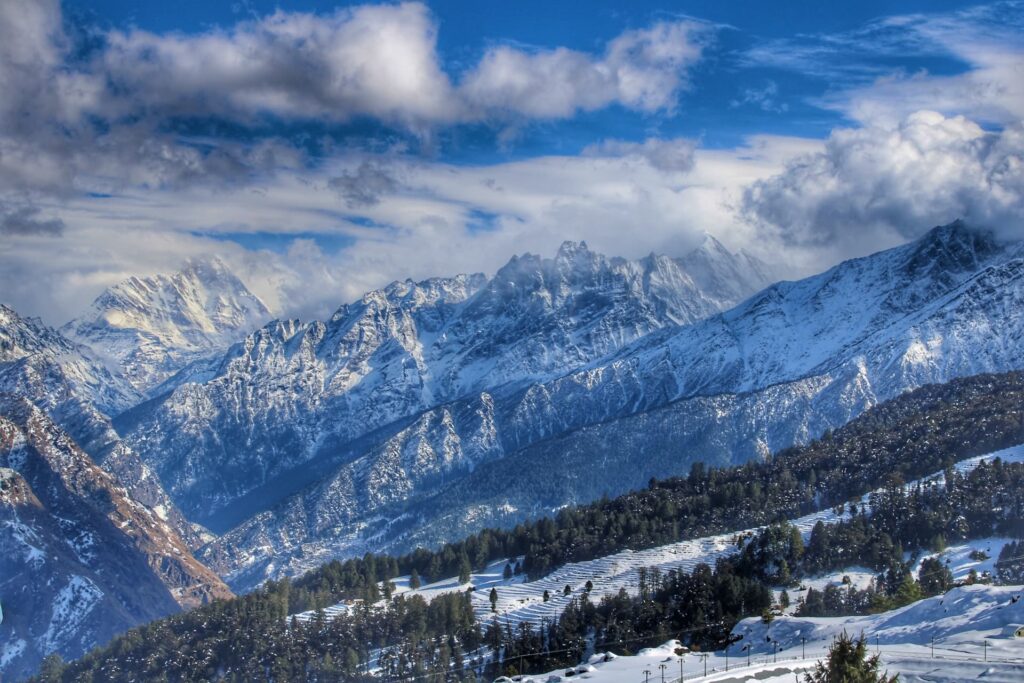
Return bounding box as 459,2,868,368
507,585,1024,683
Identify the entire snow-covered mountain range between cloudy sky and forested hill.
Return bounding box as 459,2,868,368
0,222,1024,679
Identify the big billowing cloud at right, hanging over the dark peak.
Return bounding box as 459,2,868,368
742,111,1024,252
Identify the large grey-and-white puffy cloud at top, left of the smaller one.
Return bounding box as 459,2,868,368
101,3,460,127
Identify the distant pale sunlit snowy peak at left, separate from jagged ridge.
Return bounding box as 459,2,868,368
60,257,270,392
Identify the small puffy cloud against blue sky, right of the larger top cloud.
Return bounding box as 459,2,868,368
460,20,711,119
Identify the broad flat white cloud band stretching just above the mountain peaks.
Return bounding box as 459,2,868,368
0,137,808,324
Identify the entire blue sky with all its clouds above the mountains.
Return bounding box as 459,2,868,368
6,0,1024,323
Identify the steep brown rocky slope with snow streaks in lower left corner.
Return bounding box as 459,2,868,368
0,394,229,679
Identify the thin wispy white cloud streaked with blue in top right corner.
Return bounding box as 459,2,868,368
742,0,1024,127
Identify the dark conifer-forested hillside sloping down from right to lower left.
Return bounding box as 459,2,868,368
28,372,1024,681
